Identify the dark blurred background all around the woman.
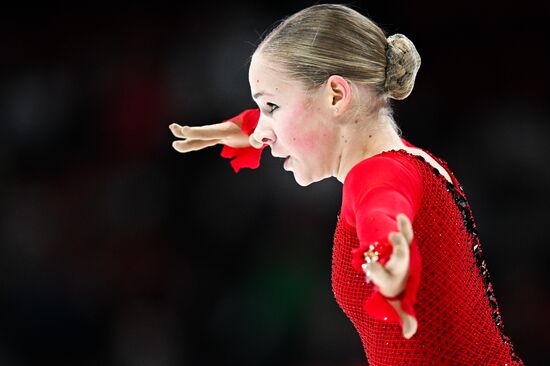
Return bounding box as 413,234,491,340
0,0,550,366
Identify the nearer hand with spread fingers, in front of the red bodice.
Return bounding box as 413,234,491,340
363,214,418,339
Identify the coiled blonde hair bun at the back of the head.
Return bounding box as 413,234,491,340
384,33,420,100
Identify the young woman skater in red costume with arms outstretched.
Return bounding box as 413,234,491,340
170,4,523,365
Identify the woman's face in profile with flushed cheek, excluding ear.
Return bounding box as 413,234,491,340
249,53,339,186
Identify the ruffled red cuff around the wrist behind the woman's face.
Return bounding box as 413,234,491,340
221,108,265,173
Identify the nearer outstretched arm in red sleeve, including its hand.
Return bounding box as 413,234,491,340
348,155,423,338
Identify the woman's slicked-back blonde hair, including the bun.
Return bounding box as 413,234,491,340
256,4,420,99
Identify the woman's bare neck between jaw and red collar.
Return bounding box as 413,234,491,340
335,116,405,183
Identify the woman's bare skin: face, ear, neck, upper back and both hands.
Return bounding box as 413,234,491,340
170,52,451,339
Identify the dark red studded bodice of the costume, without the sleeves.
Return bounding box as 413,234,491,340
332,151,523,366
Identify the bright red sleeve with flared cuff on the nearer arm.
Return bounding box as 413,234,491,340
342,154,422,323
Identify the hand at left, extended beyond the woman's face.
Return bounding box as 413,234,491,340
169,121,262,153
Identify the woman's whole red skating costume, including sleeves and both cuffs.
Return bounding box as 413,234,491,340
221,110,523,366
